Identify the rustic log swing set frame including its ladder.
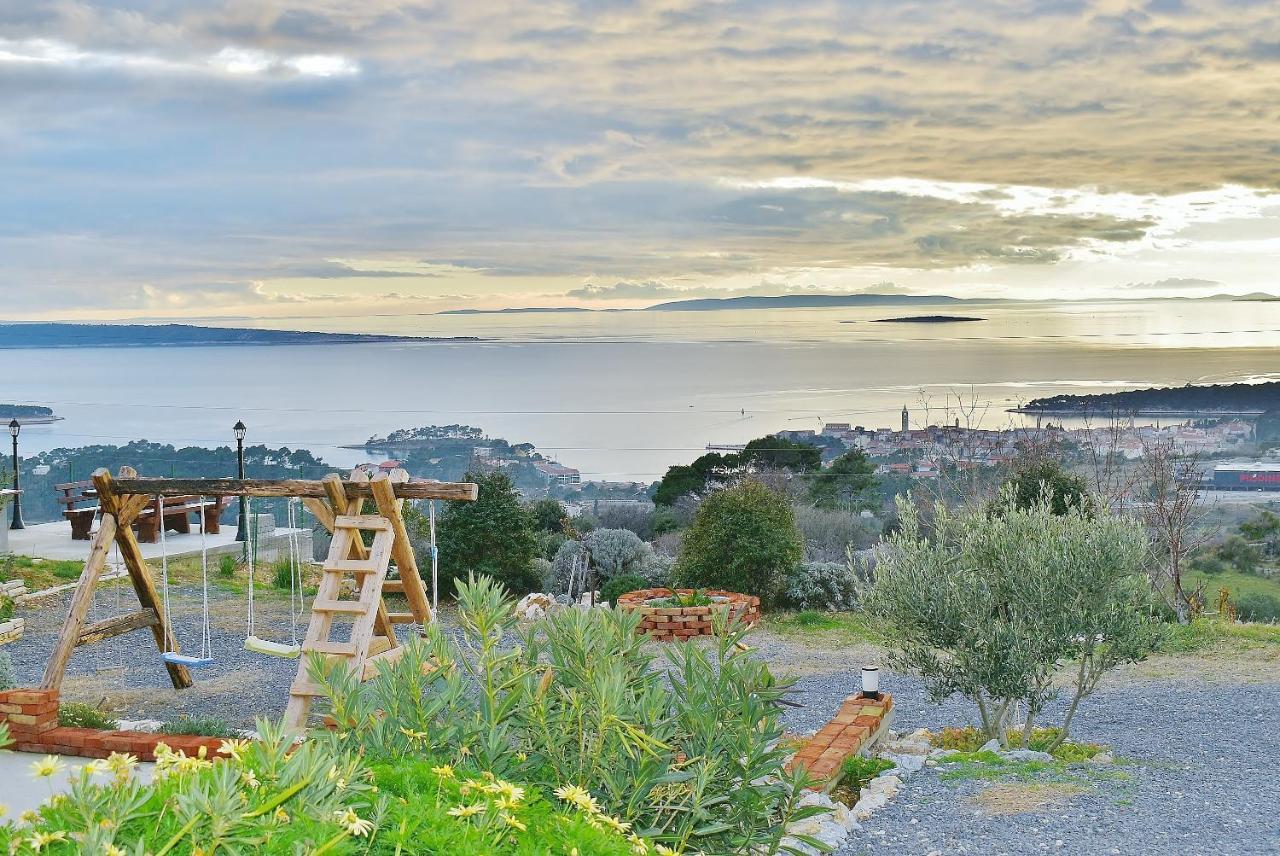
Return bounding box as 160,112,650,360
41,467,479,731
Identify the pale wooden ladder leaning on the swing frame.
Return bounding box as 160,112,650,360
284,514,404,731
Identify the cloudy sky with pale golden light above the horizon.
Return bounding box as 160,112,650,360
0,0,1280,320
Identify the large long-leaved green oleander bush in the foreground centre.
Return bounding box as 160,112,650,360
308,578,814,853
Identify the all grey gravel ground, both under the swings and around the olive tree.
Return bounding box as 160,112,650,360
6,589,1280,856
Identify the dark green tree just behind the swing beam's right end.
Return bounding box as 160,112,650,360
436,472,541,595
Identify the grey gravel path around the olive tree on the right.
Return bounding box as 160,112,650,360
787,670,1280,856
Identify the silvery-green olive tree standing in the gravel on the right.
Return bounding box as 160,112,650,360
868,489,1160,746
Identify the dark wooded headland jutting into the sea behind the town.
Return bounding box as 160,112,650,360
1010,381,1280,416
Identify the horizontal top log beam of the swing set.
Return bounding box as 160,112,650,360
115,479,480,500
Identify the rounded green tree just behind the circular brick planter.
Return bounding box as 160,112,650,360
675,480,804,603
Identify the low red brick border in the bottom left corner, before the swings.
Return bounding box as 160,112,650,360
0,690,225,761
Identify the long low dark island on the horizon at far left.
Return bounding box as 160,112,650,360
0,324,479,348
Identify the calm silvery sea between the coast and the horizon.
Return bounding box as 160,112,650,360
0,302,1280,480
